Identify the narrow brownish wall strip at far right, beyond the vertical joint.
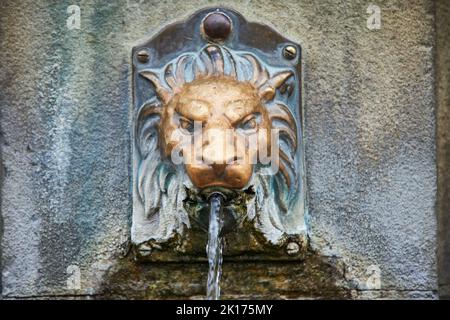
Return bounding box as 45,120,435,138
436,0,450,299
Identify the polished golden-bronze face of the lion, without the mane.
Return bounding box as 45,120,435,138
160,76,270,189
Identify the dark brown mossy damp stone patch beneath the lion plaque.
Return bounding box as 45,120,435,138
99,252,351,299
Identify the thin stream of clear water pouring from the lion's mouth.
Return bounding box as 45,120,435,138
206,194,223,300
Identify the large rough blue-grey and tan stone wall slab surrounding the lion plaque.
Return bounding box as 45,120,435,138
0,0,437,298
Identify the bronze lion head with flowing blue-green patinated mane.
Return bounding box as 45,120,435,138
132,12,304,256
